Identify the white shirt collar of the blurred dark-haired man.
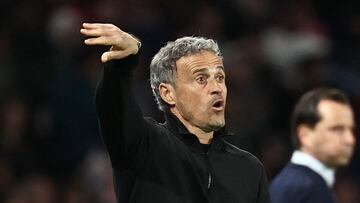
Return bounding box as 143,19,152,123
291,150,335,187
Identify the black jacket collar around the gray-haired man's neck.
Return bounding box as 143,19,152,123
164,112,234,150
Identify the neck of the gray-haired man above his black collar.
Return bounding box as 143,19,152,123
170,109,214,144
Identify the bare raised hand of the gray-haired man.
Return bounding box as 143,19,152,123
80,23,140,62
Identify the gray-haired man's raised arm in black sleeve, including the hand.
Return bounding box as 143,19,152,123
80,23,148,169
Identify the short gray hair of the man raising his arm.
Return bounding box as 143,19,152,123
150,37,222,111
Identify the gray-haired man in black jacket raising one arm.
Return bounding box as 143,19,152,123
81,23,269,203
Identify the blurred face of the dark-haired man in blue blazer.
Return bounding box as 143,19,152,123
307,100,355,168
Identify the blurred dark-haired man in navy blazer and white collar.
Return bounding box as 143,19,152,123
270,88,355,203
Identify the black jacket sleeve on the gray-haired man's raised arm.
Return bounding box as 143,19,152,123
95,54,149,170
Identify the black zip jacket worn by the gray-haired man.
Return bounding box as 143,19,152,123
96,55,269,203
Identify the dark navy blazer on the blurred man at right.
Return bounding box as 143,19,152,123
270,163,335,203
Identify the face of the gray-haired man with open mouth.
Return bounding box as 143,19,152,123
174,51,227,132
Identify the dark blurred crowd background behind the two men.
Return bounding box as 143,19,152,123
0,0,360,203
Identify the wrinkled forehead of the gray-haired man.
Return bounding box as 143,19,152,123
176,51,223,72
